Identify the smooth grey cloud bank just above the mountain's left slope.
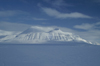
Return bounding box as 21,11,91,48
0,22,32,31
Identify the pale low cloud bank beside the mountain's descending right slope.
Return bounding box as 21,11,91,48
74,30,100,43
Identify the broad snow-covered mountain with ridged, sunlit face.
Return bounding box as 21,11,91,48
0,27,95,44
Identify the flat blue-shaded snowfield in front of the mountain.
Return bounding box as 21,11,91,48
0,44,100,66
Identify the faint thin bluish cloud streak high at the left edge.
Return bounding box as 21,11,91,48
0,10,29,17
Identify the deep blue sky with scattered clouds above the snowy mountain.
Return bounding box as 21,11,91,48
0,0,100,42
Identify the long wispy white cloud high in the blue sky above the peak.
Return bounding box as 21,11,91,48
42,8,92,18
